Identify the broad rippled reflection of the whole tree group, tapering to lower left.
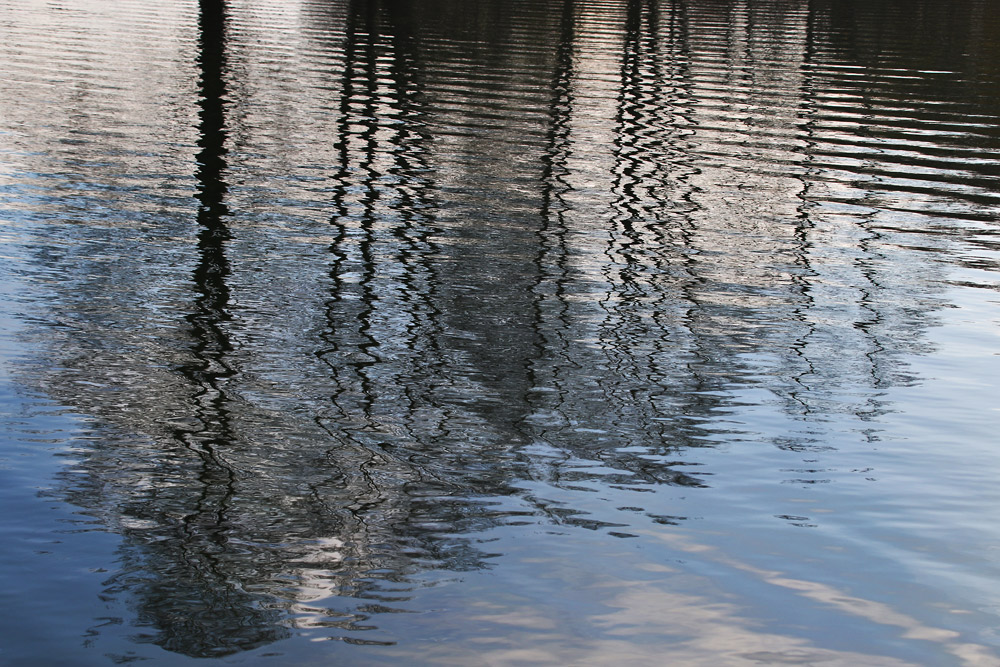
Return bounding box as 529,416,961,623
11,0,989,657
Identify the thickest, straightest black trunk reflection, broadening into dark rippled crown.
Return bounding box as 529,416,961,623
131,0,287,658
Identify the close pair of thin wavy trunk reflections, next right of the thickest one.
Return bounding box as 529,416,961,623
316,0,391,604
